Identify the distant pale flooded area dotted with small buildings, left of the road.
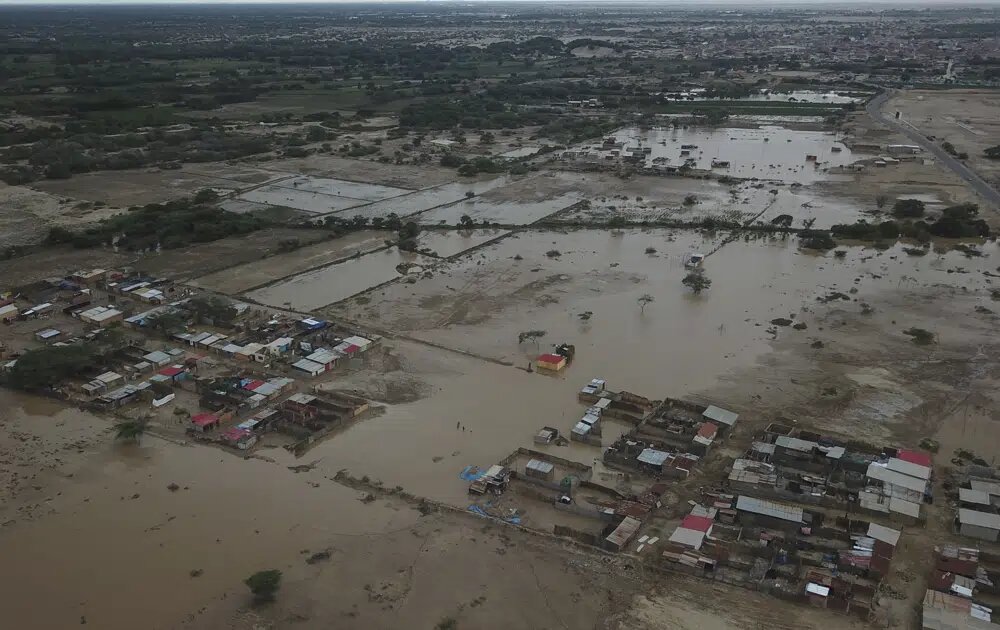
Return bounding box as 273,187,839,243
596,127,857,184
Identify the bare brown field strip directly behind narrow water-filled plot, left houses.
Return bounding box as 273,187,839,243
190,230,394,294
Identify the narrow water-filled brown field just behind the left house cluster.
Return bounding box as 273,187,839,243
247,247,433,311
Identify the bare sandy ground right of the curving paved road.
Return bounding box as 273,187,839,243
885,90,1000,186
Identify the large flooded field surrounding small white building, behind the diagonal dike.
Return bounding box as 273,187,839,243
333,230,996,382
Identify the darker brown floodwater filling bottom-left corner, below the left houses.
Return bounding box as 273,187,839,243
0,390,419,630
